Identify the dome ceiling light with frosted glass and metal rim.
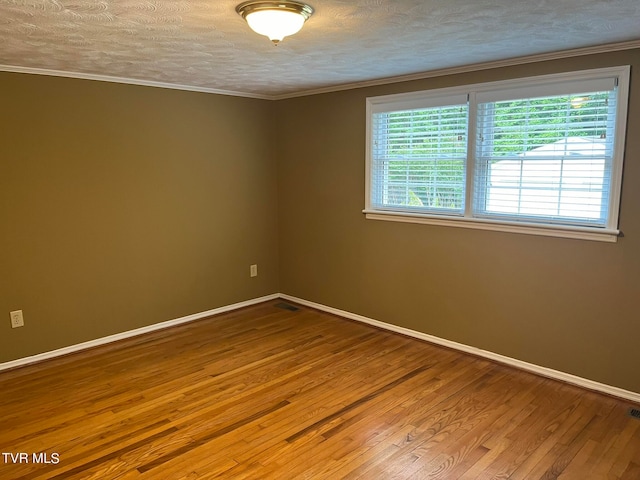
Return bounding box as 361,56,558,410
236,1,313,45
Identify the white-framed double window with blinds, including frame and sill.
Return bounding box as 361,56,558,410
365,67,629,241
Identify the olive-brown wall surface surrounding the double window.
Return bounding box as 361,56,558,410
277,50,640,392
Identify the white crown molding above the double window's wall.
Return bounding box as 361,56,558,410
270,40,640,100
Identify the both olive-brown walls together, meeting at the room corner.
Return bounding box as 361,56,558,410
0,50,640,392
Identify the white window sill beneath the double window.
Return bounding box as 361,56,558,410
363,210,620,243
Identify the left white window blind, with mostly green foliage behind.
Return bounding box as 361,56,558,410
371,101,468,214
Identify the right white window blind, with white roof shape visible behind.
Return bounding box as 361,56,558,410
474,87,616,226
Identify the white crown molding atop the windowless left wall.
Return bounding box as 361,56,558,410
0,65,274,100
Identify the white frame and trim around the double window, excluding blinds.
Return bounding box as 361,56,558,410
363,65,631,242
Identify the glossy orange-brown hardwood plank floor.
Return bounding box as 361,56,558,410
0,301,640,480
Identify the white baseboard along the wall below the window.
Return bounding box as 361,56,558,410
280,294,640,403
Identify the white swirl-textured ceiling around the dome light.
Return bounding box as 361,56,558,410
0,0,640,96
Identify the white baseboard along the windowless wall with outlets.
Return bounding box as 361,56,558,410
0,293,280,372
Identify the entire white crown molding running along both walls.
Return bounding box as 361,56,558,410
0,40,640,100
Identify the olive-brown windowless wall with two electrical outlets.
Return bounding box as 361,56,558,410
0,73,278,362
